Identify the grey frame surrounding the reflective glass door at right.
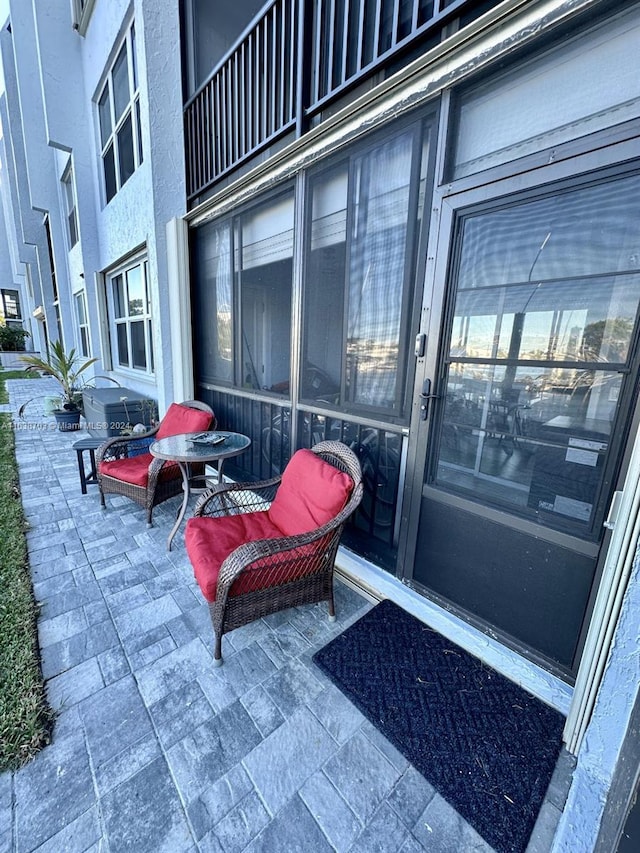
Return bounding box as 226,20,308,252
398,131,640,676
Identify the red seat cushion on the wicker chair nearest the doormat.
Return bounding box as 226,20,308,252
184,512,282,601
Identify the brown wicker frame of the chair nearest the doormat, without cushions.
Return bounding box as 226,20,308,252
188,441,363,666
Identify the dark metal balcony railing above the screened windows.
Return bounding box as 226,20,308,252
185,0,501,201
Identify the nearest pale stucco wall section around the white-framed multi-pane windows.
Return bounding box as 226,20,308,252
77,0,186,411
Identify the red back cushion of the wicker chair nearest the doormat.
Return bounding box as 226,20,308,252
269,450,353,536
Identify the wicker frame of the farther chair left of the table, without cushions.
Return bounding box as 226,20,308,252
96,400,216,527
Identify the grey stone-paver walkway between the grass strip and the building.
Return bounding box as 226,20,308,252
0,380,568,853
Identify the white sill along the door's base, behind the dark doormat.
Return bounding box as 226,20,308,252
336,548,573,714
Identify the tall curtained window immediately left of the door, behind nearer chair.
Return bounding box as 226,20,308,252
300,125,428,417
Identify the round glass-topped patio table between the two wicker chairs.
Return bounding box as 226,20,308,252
149,430,251,551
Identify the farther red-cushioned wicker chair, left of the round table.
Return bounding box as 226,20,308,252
96,400,216,526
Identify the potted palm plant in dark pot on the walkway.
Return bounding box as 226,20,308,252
18,341,99,431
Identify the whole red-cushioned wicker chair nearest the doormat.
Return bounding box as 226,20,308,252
185,441,362,666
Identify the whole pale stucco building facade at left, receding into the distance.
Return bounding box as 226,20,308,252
2,0,186,411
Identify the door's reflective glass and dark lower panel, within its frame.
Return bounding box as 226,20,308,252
414,176,640,670
